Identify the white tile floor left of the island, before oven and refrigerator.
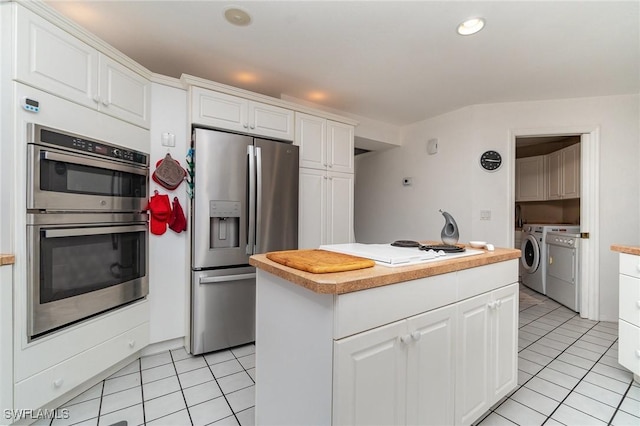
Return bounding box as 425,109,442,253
36,344,255,426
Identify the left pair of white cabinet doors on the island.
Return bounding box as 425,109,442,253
334,306,456,425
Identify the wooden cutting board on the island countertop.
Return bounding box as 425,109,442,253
267,249,376,274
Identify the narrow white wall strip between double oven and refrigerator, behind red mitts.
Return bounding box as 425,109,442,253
149,83,191,344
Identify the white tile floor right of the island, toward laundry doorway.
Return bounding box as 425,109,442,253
476,285,640,426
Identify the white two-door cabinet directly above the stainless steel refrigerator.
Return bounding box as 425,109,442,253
191,87,293,141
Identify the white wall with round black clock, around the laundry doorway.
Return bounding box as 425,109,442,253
355,95,640,319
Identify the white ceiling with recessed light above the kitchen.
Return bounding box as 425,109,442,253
46,0,640,125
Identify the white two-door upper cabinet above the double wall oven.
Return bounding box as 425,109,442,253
15,7,151,128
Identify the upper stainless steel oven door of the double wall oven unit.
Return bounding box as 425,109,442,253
27,144,149,212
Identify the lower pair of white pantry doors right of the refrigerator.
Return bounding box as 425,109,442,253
298,168,354,249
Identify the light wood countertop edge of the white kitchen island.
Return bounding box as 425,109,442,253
249,248,520,294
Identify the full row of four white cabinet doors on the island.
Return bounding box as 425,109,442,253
333,284,518,425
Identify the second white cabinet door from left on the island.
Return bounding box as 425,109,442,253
407,306,456,426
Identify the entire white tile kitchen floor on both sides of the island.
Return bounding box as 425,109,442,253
37,286,640,426
